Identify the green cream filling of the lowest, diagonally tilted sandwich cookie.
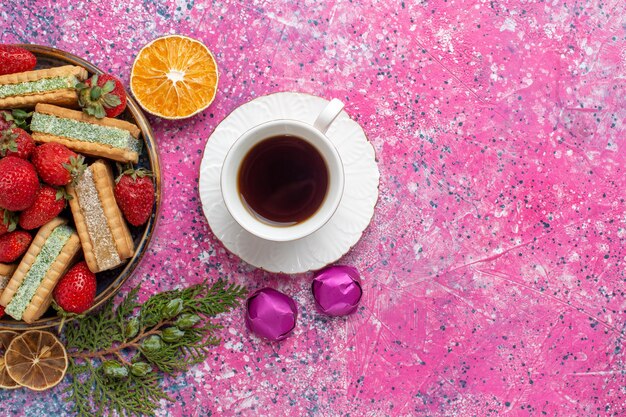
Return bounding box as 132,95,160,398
5,224,73,320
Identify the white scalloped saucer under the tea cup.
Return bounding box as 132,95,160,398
199,93,380,274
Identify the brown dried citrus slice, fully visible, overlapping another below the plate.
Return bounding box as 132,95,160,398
4,330,67,391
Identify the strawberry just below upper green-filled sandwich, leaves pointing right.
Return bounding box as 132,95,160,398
31,142,85,185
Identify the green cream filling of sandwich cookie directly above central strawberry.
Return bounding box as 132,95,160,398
30,113,141,153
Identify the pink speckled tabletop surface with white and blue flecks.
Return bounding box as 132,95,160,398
0,0,626,416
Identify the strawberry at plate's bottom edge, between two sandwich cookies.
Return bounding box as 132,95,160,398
52,261,96,314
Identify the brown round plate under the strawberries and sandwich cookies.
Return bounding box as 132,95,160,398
0,44,161,330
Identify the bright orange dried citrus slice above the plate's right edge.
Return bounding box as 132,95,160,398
130,35,219,119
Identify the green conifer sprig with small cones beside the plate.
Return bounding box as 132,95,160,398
61,280,247,417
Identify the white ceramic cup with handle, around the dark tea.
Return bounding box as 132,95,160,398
220,99,344,242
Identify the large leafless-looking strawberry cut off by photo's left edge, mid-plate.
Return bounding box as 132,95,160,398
0,156,39,211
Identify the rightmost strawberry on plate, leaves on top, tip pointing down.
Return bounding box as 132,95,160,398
113,167,154,226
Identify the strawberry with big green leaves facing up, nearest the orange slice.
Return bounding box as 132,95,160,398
76,74,126,119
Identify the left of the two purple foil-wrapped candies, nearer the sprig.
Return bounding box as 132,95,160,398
246,288,298,340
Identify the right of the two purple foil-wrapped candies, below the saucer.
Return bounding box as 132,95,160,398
311,265,363,316
